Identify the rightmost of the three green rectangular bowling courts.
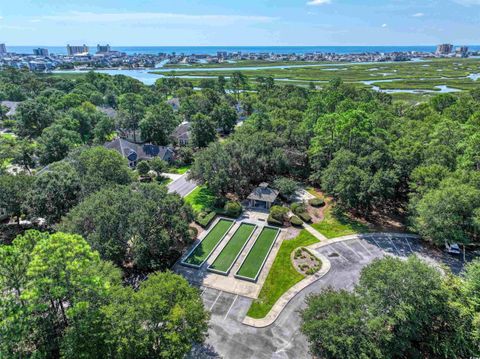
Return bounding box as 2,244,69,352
237,227,279,280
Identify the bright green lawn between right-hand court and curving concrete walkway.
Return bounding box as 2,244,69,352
247,230,318,319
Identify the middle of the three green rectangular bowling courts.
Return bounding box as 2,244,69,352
209,223,255,274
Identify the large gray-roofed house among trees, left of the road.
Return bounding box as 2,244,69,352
104,138,175,168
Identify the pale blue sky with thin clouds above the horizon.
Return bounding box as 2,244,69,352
0,0,480,46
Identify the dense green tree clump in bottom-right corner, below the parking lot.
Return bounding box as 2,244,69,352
302,257,479,358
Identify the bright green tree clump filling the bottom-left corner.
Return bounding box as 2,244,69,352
0,231,208,359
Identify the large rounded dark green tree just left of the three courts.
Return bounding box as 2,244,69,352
60,184,192,270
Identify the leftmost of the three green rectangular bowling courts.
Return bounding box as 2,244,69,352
184,219,233,266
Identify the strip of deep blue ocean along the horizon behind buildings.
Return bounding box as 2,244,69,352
7,45,480,55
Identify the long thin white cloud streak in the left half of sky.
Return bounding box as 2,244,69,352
42,11,276,25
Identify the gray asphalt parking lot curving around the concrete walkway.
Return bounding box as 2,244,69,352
190,235,470,359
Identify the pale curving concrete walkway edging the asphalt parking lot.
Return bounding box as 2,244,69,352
242,233,420,328
